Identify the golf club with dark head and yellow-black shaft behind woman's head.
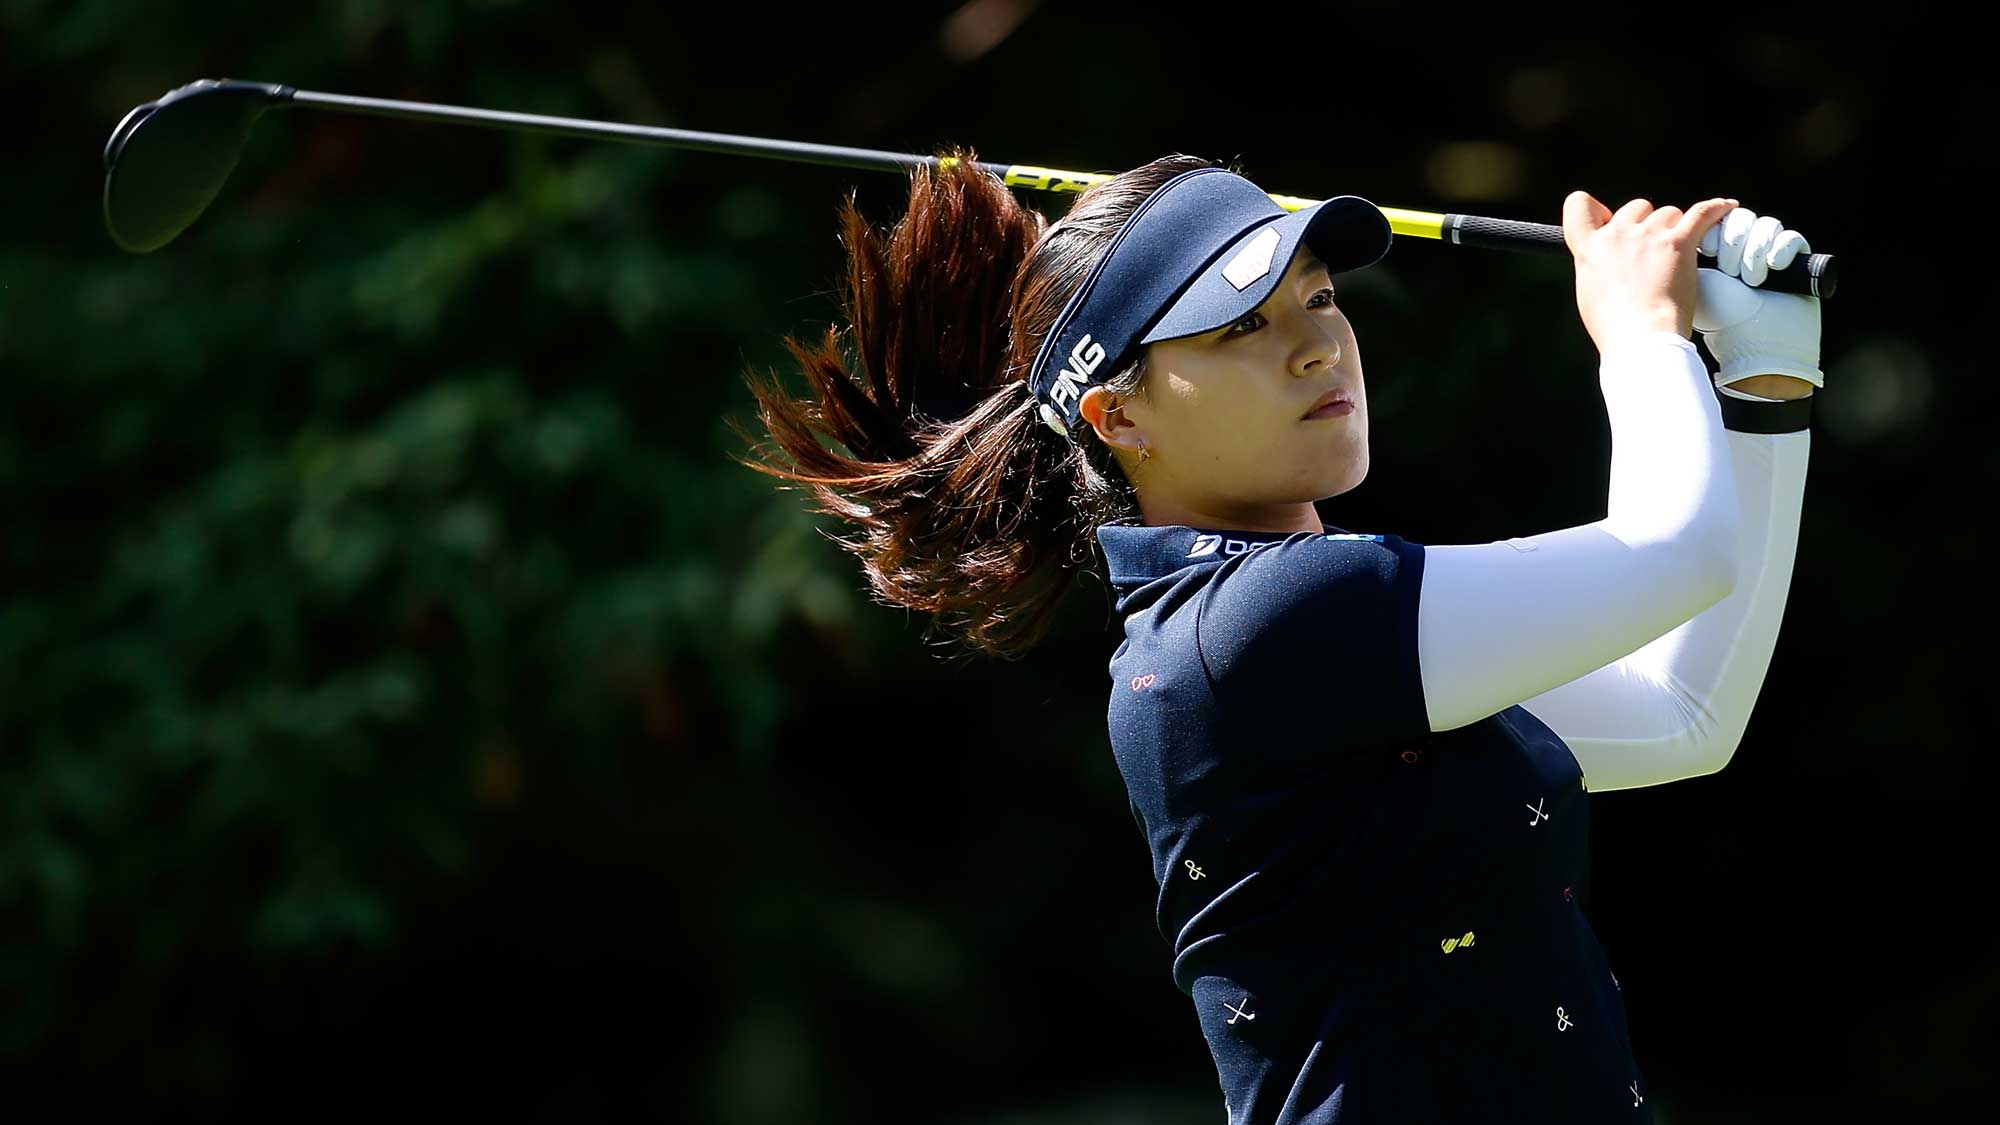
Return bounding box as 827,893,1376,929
104,78,1838,300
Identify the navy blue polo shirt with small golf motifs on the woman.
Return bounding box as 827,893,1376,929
1098,524,1652,1125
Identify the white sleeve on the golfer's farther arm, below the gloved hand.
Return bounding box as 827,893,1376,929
1522,420,1812,793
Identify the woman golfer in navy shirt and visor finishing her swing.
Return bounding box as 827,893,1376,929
746,154,1822,1125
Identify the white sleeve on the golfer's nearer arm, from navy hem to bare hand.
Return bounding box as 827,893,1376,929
1418,332,1742,731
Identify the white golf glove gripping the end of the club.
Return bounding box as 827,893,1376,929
1694,206,1826,386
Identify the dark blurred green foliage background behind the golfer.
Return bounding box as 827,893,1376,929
0,0,2000,1125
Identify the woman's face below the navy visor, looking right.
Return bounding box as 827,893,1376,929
1108,248,1368,526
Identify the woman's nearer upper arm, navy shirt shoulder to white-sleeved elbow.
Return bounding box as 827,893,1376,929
1196,524,1736,745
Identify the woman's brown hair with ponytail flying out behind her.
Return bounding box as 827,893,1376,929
732,152,1210,657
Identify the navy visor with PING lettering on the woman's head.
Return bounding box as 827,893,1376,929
1028,168,1392,436
